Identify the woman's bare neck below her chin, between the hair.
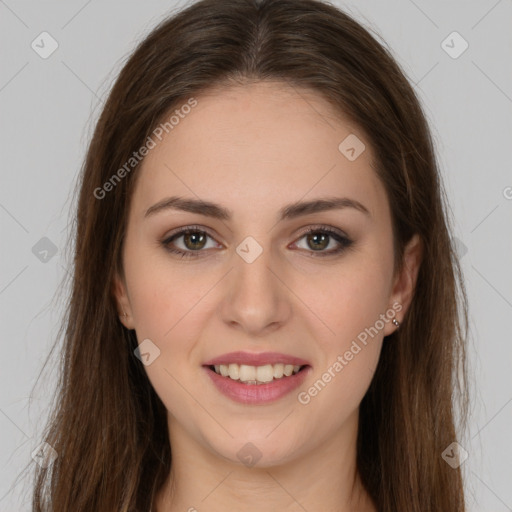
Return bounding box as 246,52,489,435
153,411,376,512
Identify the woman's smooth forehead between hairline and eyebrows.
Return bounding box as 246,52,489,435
133,83,386,221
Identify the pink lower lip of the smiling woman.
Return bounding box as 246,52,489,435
204,366,311,405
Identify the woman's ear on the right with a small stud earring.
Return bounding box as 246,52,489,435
384,234,423,336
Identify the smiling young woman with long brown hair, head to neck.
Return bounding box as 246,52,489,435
33,0,467,512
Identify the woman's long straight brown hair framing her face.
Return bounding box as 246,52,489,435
28,0,468,512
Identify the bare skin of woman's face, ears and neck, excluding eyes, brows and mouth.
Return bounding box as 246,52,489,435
113,82,421,512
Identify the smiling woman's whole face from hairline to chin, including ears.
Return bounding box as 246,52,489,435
115,83,417,465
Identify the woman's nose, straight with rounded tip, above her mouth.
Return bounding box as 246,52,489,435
221,242,292,337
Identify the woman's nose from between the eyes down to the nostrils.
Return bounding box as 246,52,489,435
223,237,290,334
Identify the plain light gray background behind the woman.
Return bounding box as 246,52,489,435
0,0,512,512
